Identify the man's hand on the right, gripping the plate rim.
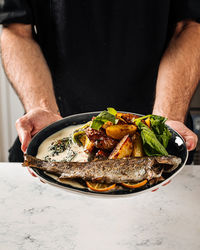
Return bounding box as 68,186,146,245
166,120,198,151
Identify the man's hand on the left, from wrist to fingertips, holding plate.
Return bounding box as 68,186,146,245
16,108,62,153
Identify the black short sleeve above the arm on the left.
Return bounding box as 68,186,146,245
0,0,32,24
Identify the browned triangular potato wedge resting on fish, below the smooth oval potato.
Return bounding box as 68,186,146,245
108,135,133,159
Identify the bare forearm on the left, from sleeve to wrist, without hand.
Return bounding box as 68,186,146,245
1,23,58,113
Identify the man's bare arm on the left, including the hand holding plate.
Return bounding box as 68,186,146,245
1,24,61,151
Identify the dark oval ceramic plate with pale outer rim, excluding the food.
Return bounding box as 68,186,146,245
27,111,188,197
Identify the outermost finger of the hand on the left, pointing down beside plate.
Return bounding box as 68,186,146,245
16,117,32,153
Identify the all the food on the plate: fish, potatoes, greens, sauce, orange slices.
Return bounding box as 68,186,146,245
24,108,181,192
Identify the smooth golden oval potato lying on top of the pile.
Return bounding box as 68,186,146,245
106,124,137,140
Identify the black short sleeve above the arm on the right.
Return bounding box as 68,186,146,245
170,0,200,23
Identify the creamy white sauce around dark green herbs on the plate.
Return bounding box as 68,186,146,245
36,124,88,162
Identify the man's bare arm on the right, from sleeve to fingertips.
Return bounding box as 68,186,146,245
153,21,200,150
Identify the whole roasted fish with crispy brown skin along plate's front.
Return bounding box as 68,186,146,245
23,155,181,184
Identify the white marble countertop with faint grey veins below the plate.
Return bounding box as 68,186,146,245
0,163,200,250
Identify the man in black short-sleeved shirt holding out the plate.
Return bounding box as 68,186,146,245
0,0,200,161
